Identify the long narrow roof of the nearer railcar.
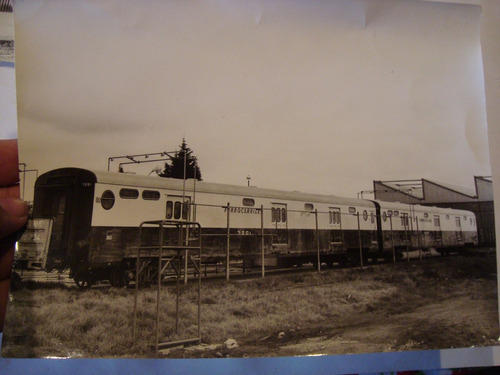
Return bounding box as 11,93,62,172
92,171,374,207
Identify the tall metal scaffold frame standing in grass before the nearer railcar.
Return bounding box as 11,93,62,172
133,220,201,354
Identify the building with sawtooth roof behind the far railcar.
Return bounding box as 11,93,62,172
373,176,495,246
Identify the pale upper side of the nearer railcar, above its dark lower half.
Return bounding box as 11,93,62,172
92,171,376,230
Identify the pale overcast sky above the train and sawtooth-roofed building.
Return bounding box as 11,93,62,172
14,0,491,198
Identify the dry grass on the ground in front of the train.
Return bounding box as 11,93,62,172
3,257,497,358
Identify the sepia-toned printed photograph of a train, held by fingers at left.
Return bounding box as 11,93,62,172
1,0,499,358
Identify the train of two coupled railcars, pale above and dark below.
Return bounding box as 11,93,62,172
14,168,477,285
